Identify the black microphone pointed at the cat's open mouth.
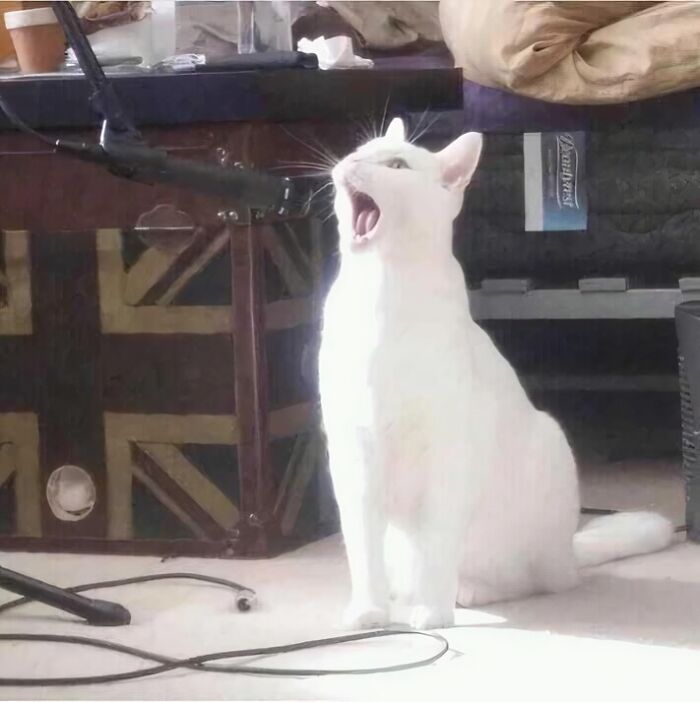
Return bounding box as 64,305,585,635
55,139,312,217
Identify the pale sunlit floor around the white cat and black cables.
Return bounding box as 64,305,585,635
0,462,700,702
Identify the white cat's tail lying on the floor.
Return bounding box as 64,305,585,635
574,512,674,568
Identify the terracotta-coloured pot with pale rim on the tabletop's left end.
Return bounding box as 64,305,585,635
5,7,66,73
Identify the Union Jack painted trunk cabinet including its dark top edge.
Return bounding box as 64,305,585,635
0,71,461,556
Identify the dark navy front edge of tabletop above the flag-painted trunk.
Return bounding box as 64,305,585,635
0,62,462,129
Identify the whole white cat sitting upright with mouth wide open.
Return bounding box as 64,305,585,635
319,119,673,629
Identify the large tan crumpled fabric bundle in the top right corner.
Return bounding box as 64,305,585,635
440,0,700,104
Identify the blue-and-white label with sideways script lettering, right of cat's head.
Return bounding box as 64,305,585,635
523,132,588,232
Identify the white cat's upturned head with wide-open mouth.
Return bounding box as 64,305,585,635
333,118,482,254
